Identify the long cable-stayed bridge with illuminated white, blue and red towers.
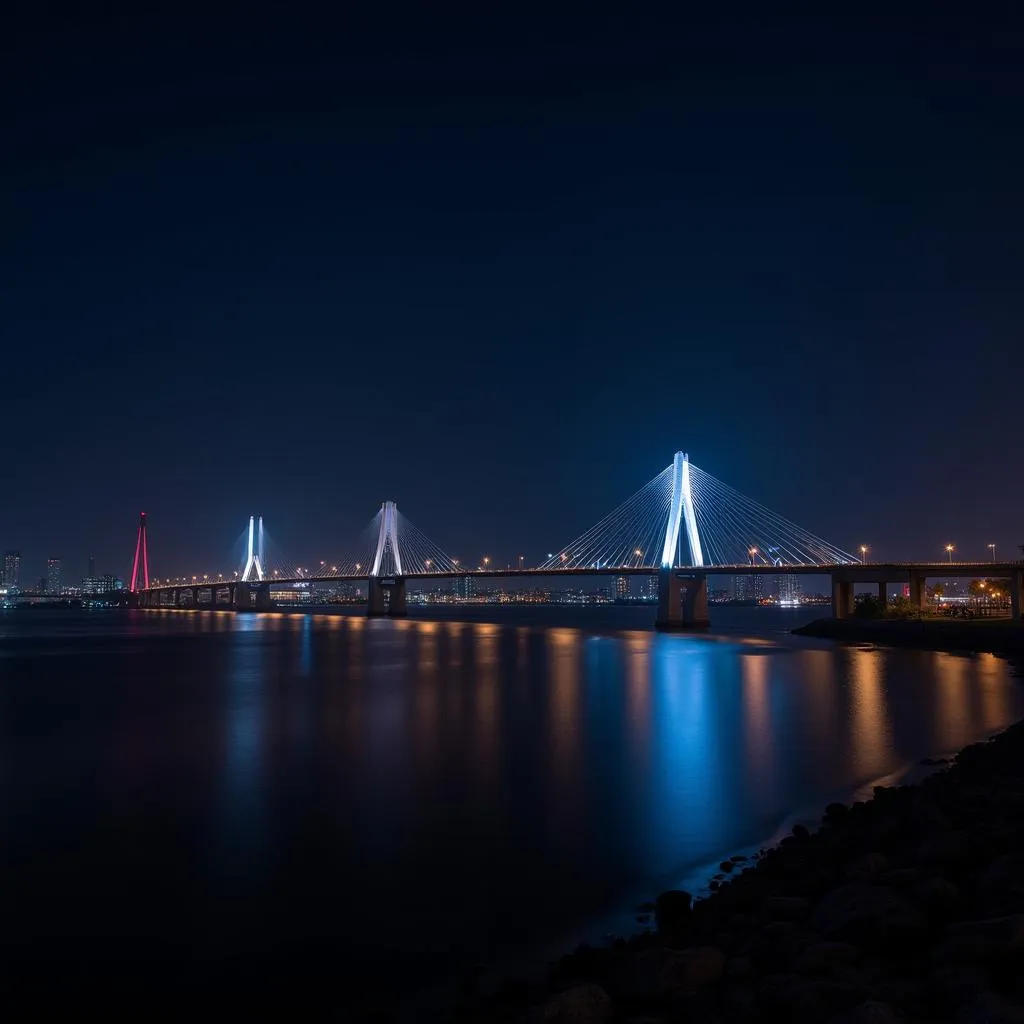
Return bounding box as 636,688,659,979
131,453,1024,630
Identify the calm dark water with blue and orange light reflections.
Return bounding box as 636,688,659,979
0,608,1024,1007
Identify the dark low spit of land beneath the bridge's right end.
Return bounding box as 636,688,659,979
793,618,1024,660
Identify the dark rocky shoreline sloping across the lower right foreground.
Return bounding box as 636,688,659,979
452,722,1024,1024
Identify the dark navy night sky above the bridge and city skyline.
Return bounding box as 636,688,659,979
0,4,1024,580
